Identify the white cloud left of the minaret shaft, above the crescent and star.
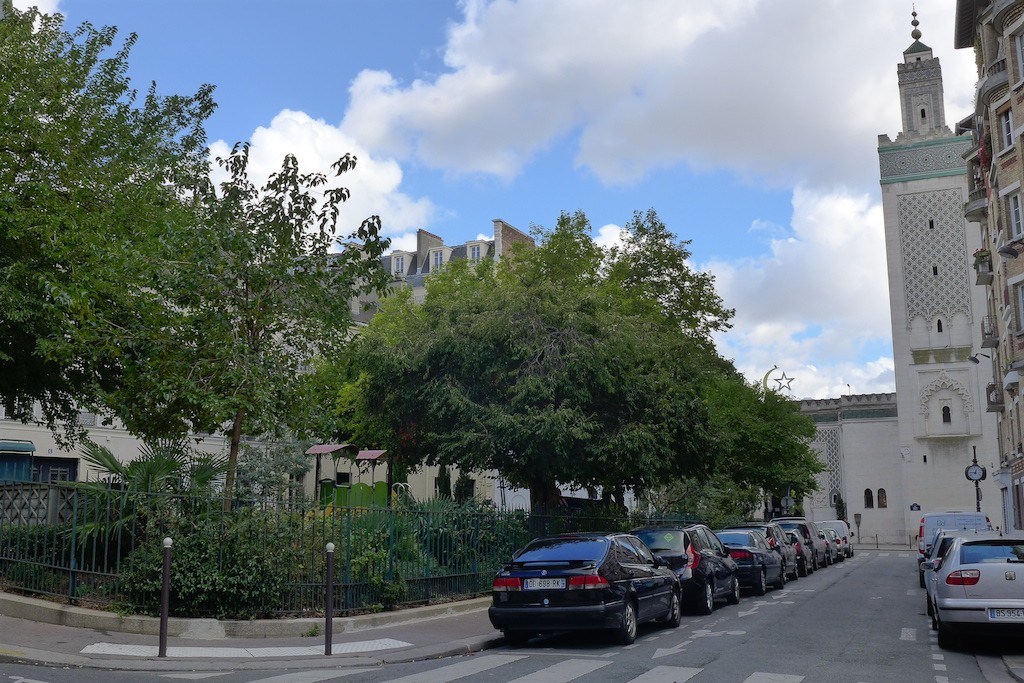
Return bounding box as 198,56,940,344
703,187,894,397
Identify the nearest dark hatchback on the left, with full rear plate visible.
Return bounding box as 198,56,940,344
487,533,681,645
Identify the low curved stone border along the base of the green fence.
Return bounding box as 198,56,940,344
0,593,490,643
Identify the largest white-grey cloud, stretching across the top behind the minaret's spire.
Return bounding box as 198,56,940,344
342,0,976,192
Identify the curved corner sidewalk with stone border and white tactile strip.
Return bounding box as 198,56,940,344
0,593,504,672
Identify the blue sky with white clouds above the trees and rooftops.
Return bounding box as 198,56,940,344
14,0,977,398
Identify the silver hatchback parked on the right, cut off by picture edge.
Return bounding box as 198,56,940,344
928,531,1024,649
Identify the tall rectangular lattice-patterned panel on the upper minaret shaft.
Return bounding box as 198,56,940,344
899,188,972,329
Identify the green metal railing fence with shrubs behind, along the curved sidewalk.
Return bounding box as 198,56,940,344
0,483,692,618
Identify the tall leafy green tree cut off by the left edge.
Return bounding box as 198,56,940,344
0,0,214,440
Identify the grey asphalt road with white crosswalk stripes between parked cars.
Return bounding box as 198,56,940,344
0,550,1024,683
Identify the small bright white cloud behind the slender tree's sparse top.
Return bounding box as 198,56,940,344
210,110,435,239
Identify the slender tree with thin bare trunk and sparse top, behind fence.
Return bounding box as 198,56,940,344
105,144,388,508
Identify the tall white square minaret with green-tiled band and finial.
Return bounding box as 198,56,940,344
872,11,999,540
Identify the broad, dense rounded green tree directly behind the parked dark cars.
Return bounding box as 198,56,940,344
346,213,726,509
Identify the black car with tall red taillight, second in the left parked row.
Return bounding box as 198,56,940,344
633,524,739,614
